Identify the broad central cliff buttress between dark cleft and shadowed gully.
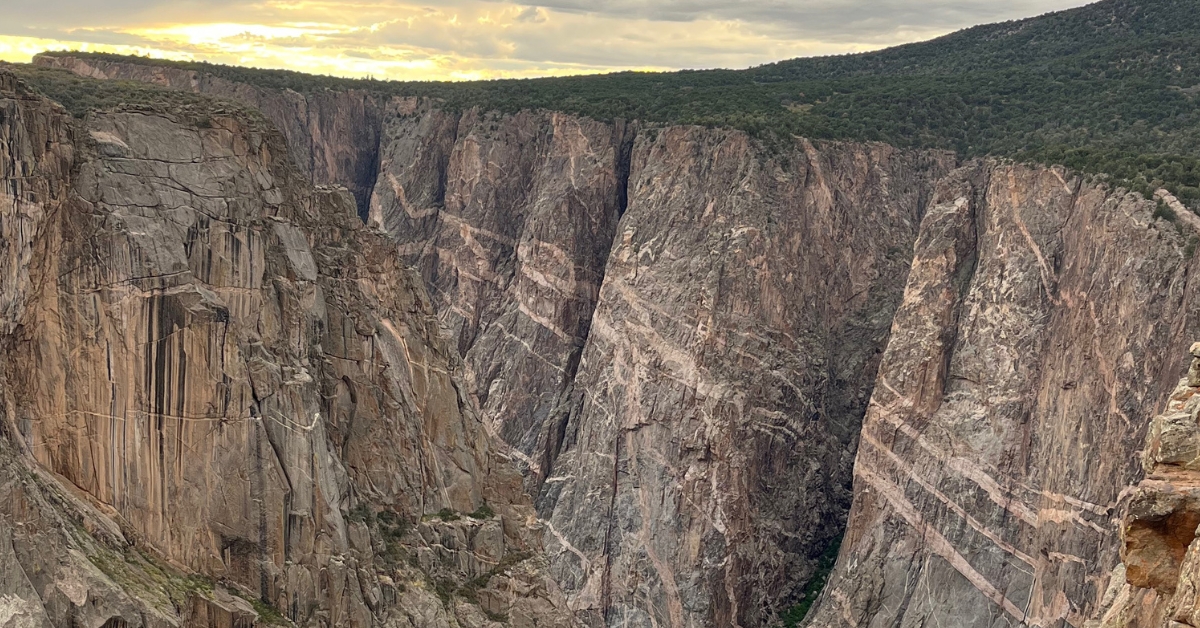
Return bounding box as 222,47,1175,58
539,128,953,627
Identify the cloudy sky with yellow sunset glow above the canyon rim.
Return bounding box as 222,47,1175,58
0,0,1086,80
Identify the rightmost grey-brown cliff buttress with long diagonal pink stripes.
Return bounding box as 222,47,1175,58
809,163,1200,627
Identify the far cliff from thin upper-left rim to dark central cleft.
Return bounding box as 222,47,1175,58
28,55,634,478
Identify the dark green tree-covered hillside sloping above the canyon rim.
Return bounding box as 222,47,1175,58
32,0,1200,207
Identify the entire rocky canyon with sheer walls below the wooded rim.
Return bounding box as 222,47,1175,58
0,50,1200,628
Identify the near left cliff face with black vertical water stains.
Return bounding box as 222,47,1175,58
0,74,574,627
